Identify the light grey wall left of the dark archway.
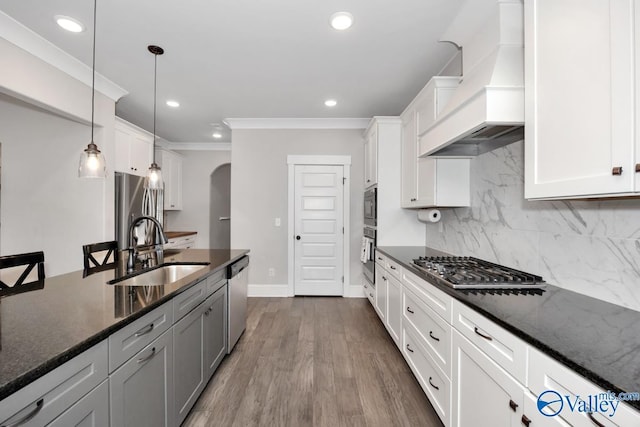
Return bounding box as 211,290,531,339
165,150,231,248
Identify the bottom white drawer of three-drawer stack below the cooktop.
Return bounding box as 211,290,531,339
402,325,451,426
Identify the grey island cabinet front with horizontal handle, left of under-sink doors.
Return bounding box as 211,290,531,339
109,330,175,427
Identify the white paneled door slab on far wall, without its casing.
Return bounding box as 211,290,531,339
294,165,344,295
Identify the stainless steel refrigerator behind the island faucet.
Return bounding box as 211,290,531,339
115,172,164,250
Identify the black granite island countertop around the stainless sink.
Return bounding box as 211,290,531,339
0,249,249,400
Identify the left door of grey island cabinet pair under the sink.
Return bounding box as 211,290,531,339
173,302,209,426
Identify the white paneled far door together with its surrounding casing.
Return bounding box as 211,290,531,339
288,156,351,296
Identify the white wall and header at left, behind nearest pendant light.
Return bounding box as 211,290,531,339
0,39,115,276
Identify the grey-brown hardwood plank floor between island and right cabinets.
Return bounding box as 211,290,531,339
183,297,442,427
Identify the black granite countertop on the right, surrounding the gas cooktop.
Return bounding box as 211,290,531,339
377,246,640,409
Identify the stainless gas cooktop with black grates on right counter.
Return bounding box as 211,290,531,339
413,256,546,289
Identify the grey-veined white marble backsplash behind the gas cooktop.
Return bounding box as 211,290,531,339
426,142,640,311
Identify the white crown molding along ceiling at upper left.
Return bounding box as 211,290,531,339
0,11,129,101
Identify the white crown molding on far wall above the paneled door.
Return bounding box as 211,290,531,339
224,118,371,130
